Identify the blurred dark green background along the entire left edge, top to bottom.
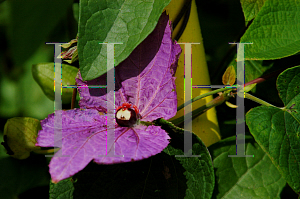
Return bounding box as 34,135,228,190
0,0,77,199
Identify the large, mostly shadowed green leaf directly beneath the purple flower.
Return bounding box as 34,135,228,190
50,124,214,199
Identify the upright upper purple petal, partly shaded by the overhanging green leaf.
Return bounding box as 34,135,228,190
76,14,181,121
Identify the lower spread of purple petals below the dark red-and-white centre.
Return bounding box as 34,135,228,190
37,109,170,182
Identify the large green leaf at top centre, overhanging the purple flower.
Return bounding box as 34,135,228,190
78,0,170,80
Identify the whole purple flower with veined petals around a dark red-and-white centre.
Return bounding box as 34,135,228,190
36,14,181,182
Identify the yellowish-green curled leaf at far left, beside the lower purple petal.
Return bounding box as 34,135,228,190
1,117,42,159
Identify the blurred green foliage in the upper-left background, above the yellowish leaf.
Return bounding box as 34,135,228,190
0,0,77,121
